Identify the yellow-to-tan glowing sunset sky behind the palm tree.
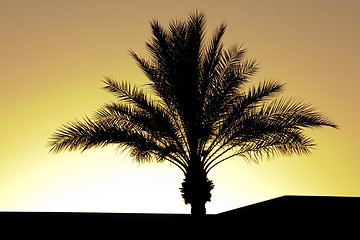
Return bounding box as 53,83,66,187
0,0,360,213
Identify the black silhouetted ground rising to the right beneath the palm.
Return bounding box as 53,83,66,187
0,196,360,236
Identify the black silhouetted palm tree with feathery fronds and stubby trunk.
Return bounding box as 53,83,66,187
50,12,337,215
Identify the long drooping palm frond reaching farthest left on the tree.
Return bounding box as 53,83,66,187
49,118,186,170
